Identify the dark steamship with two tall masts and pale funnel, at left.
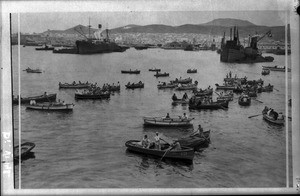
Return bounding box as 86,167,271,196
74,24,128,54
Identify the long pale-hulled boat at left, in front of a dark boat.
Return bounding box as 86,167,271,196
26,102,74,111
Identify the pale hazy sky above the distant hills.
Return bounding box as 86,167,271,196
12,11,285,33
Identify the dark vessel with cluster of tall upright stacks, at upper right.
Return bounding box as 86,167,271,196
220,27,274,63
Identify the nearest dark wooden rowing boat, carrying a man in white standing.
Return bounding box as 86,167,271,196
125,140,195,161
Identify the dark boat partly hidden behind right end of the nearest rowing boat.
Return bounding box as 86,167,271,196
176,130,210,151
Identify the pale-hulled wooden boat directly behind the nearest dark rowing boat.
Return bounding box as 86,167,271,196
144,117,194,127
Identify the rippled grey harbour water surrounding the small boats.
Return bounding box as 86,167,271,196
13,46,291,188
